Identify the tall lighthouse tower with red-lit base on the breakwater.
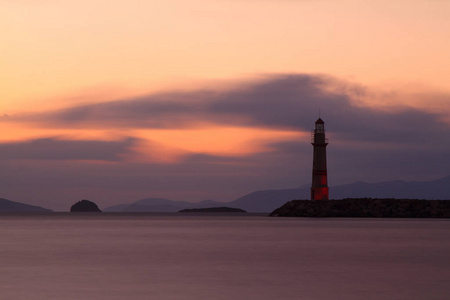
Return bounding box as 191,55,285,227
311,118,328,200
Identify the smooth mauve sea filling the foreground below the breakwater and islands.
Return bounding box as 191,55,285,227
0,213,450,300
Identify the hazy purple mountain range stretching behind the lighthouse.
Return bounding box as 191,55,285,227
103,176,450,212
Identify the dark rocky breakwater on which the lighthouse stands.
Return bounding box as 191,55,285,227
270,198,450,218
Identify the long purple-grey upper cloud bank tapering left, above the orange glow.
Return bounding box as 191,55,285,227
12,74,449,148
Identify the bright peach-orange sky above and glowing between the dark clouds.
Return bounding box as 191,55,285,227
0,0,450,176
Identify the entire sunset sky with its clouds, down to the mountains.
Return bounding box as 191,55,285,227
0,0,450,211
